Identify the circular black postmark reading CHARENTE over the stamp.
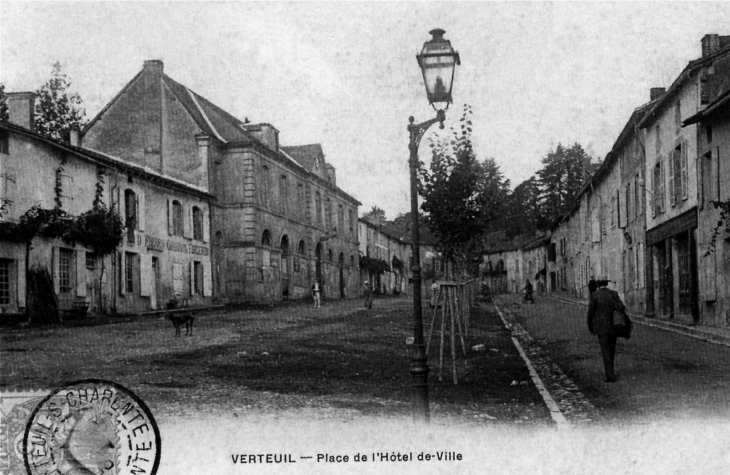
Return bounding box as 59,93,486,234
20,379,160,475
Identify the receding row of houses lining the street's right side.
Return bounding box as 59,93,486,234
483,34,730,326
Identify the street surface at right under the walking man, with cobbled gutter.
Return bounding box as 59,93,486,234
497,295,730,424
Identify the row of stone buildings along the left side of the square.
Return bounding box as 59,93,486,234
0,60,376,313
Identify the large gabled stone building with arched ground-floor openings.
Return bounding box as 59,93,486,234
82,60,360,301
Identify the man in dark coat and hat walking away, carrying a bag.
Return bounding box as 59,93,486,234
588,280,625,383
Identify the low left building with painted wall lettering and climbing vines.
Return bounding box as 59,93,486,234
0,93,214,313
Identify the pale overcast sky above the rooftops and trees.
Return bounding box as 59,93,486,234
0,1,730,219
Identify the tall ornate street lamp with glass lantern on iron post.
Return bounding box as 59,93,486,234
408,28,461,423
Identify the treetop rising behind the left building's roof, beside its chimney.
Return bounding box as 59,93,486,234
35,62,86,141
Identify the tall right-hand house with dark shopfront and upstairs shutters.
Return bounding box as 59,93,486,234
639,35,730,322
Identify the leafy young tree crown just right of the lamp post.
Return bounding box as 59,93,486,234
419,105,508,277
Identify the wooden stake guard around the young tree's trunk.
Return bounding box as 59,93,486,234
426,282,468,384
